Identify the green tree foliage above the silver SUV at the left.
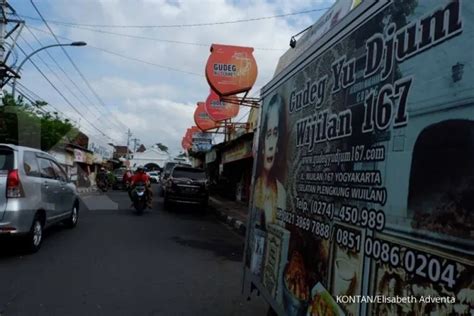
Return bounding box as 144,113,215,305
0,92,79,150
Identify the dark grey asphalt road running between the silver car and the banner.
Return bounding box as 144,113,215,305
0,186,267,316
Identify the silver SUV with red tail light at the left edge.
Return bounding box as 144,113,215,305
0,144,79,252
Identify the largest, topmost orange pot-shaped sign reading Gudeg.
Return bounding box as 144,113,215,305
206,44,257,96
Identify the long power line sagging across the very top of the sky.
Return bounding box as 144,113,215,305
21,8,329,28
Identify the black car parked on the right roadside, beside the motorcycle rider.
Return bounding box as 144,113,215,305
163,165,209,210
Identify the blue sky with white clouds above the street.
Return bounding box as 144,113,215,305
9,0,334,154
